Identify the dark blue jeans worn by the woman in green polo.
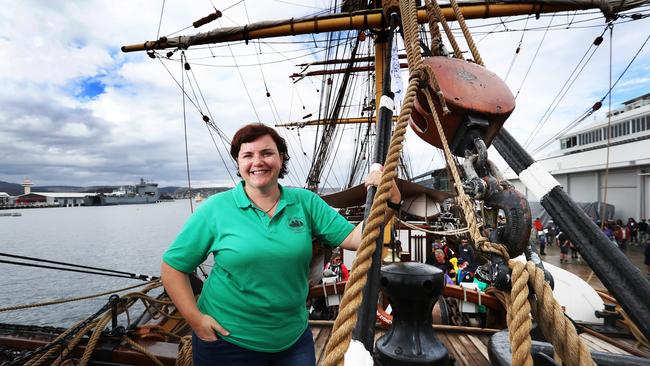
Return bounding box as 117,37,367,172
192,327,316,366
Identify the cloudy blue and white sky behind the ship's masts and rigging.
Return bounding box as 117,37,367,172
0,0,650,187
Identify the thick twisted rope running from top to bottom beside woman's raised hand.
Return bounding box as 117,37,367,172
323,1,422,366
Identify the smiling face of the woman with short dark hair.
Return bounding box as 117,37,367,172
237,135,282,190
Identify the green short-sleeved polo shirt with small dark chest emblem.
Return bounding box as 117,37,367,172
163,181,354,352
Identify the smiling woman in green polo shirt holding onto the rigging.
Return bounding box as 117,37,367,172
161,124,401,365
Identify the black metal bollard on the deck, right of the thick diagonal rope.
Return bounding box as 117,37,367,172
375,262,449,366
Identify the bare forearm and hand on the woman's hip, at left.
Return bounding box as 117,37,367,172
160,261,230,341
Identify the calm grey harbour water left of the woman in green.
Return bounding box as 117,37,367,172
0,200,195,327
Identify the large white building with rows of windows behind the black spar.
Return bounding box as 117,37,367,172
511,93,650,221
